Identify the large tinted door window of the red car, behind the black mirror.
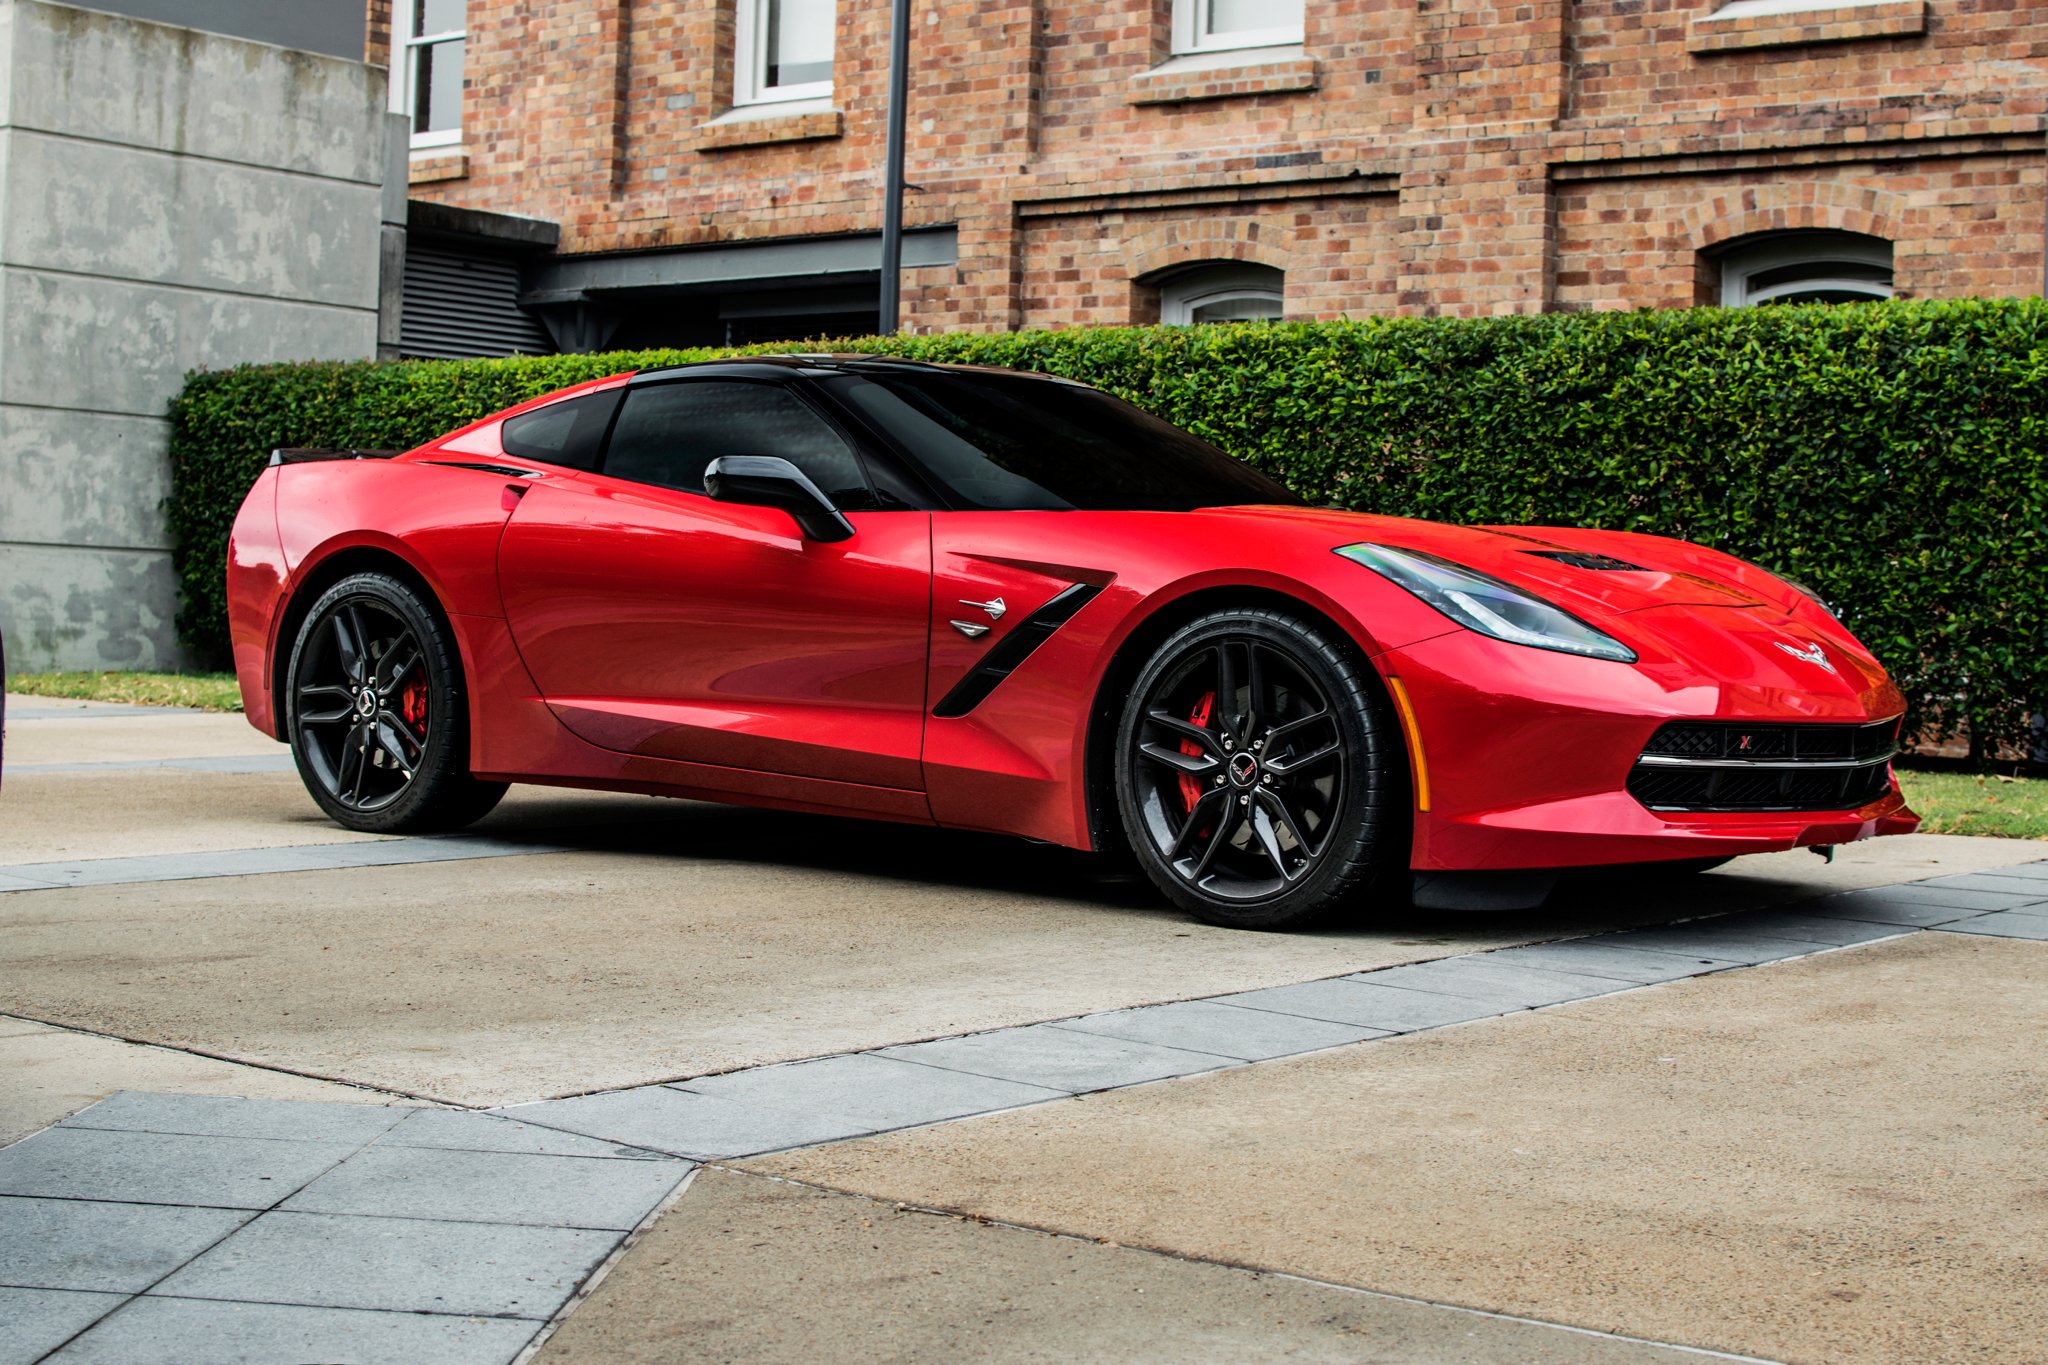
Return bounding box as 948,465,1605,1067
604,379,872,510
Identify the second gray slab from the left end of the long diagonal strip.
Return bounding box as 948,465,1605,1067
674,1052,1067,1130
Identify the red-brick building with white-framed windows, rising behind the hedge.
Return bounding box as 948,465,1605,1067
369,0,2048,354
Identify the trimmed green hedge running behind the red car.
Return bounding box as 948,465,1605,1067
170,299,2048,757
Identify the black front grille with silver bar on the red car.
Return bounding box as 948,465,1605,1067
1628,718,1898,810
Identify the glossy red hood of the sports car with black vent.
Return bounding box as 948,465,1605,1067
1225,508,1800,618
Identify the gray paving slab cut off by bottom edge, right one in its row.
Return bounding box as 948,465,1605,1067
51,1295,541,1365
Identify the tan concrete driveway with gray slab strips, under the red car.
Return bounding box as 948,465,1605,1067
0,698,2048,1361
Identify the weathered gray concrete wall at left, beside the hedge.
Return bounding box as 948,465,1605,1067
0,0,389,669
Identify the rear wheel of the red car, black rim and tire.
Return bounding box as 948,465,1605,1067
285,573,506,835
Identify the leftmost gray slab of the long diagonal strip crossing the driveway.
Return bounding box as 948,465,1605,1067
502,1085,874,1160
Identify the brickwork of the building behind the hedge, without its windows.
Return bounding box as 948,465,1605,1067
385,0,2048,329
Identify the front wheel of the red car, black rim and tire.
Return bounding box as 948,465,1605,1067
1116,608,1409,929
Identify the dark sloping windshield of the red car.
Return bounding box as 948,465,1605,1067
823,366,1300,512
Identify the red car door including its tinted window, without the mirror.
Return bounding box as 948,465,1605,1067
498,379,932,790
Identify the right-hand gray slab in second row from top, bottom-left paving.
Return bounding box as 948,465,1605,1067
279,1146,690,1232
